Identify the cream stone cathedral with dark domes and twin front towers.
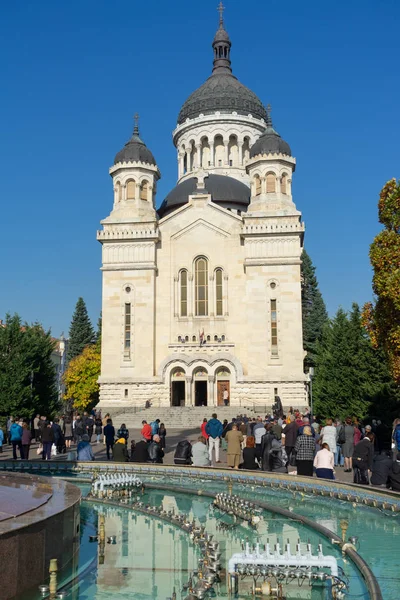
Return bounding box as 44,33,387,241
97,5,305,409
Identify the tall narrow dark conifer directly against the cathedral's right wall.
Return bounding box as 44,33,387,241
301,249,328,371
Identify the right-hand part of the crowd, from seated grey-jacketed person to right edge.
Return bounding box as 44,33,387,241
186,409,400,491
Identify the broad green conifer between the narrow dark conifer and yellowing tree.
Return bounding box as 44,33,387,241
313,304,393,418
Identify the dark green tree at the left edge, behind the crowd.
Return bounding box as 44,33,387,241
0,315,58,417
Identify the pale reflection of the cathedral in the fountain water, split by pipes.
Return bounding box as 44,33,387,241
96,492,318,600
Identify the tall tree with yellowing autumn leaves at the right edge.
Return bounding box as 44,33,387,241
363,179,400,383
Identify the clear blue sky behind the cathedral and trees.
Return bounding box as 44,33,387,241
0,0,400,335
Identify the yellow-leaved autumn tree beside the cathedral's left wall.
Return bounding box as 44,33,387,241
63,344,101,410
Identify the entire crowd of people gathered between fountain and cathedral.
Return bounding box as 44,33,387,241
0,408,400,491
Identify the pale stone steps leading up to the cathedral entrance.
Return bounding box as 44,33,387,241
106,406,265,429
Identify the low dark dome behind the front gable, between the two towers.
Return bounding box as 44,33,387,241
158,175,250,217
